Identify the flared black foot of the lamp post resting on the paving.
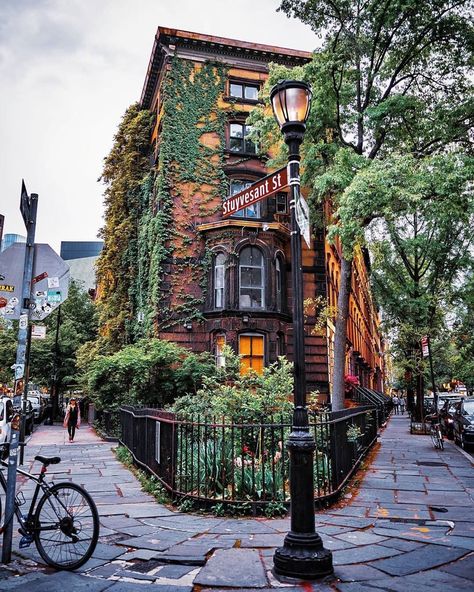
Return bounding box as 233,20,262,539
273,531,333,580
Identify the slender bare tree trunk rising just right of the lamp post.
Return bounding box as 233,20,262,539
331,257,352,411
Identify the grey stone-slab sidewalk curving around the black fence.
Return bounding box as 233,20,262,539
0,416,474,592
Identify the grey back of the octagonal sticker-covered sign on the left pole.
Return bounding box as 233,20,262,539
0,243,69,321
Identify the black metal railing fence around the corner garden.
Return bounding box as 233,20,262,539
121,406,377,512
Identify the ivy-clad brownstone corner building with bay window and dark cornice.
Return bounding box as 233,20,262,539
102,27,382,399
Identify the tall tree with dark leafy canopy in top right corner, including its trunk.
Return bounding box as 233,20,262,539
280,0,473,409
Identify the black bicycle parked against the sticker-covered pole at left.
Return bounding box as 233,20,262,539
0,443,99,571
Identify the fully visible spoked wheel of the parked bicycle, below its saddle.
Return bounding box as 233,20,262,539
34,483,99,570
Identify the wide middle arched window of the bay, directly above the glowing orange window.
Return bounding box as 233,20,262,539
239,247,265,308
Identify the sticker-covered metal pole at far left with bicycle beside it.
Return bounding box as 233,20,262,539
2,183,38,563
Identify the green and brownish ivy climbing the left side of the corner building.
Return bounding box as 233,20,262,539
98,58,227,350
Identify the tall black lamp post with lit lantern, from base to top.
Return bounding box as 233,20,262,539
270,80,333,579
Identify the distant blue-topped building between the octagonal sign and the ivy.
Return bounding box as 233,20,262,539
61,241,104,297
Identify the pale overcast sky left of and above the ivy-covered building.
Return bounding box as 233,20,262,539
0,0,317,252
